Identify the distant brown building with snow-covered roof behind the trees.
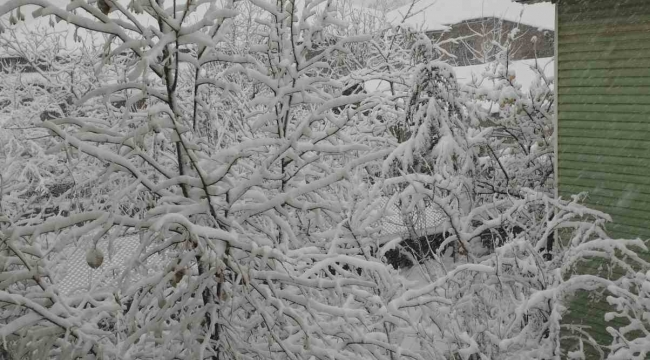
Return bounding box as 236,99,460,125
388,0,555,66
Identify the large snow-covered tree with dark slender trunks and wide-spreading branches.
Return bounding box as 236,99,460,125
0,0,394,358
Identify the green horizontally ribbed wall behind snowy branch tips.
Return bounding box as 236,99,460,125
557,0,650,354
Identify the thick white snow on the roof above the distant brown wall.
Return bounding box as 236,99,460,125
388,0,555,30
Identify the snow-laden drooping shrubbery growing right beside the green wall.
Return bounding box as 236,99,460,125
372,26,647,359
